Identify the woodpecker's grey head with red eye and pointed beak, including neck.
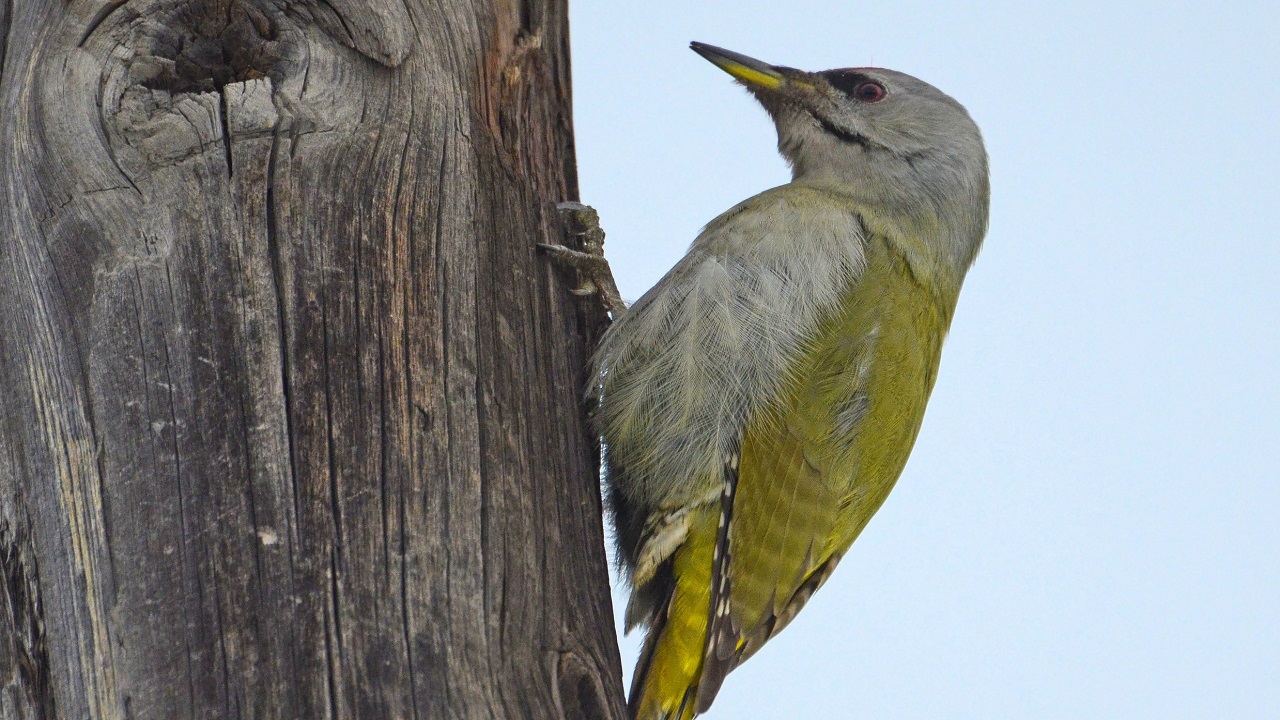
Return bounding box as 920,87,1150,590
691,42,989,262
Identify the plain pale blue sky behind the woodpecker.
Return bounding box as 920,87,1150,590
571,0,1280,720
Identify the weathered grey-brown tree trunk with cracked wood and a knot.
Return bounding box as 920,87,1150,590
0,0,622,720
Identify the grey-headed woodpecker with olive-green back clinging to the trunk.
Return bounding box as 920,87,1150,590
570,42,989,720
